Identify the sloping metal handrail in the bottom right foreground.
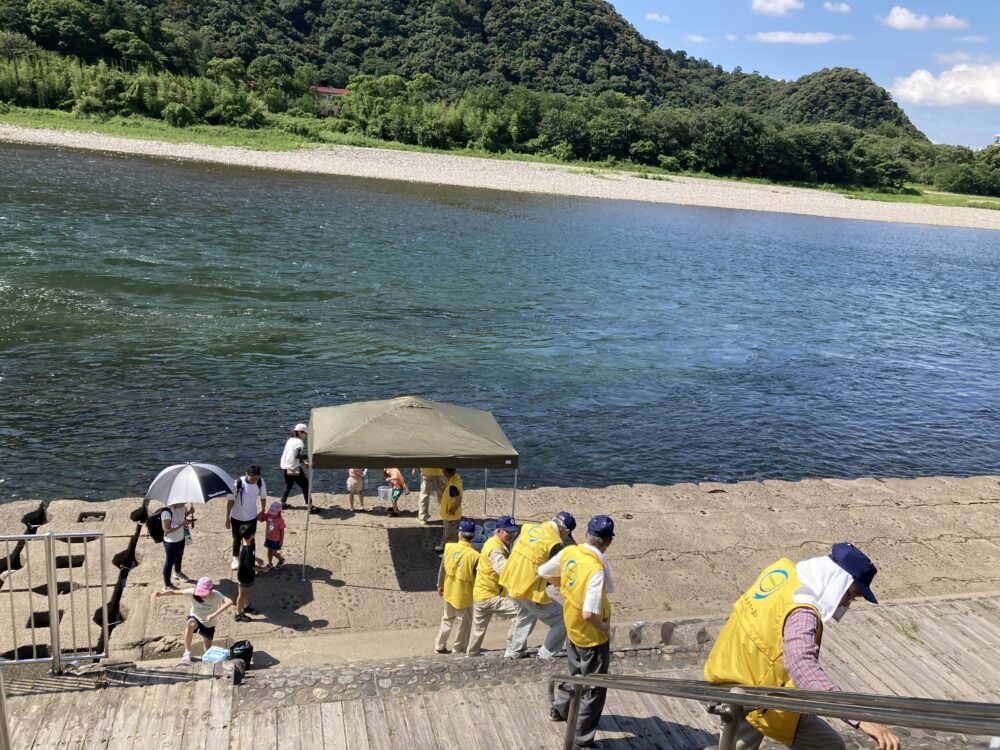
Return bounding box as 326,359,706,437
549,674,1000,750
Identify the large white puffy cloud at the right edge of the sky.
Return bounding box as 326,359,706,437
890,62,1000,107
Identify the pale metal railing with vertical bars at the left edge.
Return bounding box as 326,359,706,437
0,531,108,674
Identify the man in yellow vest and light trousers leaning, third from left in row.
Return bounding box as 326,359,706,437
500,511,576,659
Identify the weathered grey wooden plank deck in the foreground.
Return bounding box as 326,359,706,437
1,598,1000,750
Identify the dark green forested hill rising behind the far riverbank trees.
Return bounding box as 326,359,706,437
0,0,923,138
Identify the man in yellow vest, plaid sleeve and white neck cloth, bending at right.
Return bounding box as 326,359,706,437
705,542,899,750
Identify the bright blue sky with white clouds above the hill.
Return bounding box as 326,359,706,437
612,0,1000,148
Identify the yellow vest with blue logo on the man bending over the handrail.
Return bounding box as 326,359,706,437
705,558,823,745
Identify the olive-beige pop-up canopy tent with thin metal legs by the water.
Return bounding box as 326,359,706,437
302,396,518,578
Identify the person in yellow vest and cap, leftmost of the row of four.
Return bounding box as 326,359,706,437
435,521,479,654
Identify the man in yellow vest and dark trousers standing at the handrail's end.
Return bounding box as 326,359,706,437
538,516,615,748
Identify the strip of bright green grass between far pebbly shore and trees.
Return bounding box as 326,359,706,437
0,107,1000,210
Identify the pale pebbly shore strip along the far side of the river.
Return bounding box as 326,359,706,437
0,124,1000,230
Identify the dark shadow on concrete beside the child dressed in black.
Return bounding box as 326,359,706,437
218,563,344,636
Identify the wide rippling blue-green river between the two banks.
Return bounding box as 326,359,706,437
0,146,1000,500
